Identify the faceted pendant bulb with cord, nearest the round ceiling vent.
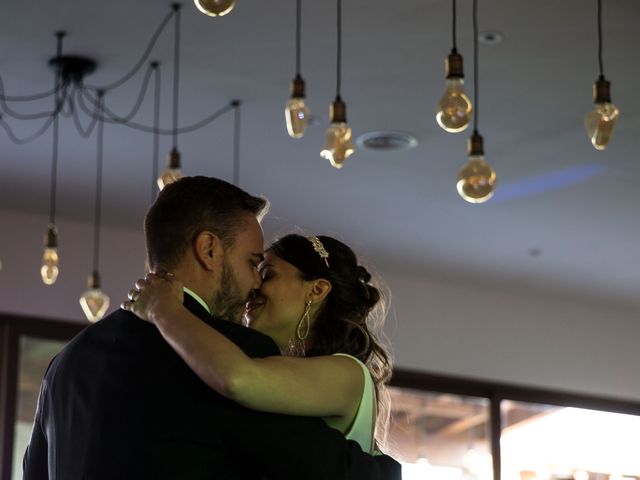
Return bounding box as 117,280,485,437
320,0,354,168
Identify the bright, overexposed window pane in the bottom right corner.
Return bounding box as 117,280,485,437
501,401,640,480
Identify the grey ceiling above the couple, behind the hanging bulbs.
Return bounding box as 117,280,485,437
0,0,640,304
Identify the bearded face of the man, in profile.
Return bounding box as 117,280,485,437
213,213,264,323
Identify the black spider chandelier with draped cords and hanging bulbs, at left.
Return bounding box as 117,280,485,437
0,1,240,321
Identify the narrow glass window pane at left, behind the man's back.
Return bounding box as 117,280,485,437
11,335,67,480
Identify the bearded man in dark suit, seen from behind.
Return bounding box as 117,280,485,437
24,177,400,480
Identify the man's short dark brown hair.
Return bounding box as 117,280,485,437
144,176,269,270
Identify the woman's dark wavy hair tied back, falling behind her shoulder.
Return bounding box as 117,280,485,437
269,234,392,446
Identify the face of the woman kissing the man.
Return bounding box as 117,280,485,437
246,251,312,349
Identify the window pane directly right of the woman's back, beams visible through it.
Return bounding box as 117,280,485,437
389,387,493,480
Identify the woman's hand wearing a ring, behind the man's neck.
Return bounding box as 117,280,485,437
121,273,184,325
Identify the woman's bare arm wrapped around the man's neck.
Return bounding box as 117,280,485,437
124,276,364,420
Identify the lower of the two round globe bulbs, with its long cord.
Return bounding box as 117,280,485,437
457,0,496,203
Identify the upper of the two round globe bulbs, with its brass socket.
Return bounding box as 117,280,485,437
436,48,473,133
